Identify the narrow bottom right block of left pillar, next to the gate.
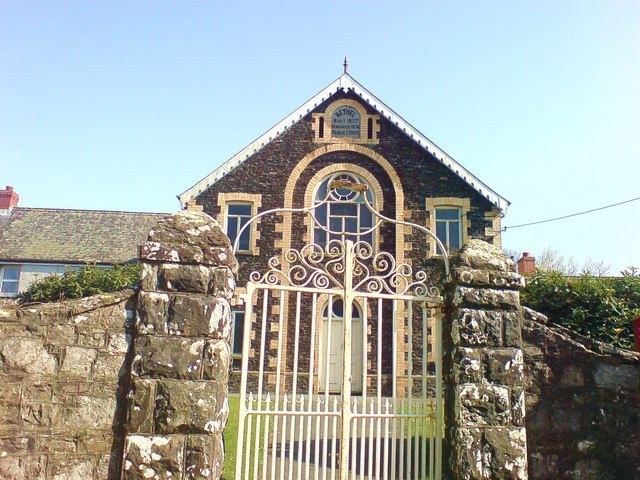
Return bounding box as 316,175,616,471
185,434,224,480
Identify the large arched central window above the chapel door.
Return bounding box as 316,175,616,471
313,172,375,247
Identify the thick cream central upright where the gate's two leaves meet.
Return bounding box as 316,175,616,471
339,240,355,480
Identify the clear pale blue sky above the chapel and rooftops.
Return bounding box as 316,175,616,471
0,0,640,273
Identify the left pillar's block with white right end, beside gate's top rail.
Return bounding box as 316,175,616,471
168,294,232,338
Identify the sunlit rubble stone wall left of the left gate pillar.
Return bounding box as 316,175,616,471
0,290,136,480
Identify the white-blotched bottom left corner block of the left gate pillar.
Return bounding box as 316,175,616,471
122,435,185,480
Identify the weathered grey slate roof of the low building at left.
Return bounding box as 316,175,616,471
0,207,168,264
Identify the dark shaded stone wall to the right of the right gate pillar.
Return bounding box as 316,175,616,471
523,309,640,480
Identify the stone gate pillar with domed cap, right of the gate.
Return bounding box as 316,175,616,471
443,240,528,480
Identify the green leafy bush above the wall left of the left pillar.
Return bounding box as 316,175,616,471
17,264,140,303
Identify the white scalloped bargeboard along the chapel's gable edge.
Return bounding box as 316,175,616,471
178,73,510,212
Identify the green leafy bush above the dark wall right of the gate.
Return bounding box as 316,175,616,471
521,269,640,349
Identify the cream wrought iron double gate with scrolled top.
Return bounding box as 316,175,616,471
236,185,446,480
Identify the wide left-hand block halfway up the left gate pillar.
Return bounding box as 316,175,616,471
132,336,205,380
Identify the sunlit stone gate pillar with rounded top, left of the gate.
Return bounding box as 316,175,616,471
122,211,236,480
